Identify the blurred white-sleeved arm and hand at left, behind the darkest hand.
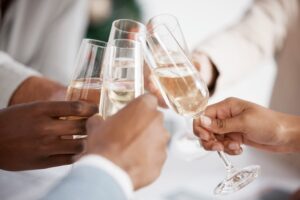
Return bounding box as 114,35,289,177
0,51,66,108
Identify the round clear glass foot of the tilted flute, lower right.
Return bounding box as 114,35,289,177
214,165,260,195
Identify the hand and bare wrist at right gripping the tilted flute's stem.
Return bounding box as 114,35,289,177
194,98,300,154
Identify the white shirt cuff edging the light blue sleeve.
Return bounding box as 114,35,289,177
74,154,133,199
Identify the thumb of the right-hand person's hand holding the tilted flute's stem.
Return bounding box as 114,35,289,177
200,115,241,134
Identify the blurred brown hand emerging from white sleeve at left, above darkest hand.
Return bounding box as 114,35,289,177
9,76,67,105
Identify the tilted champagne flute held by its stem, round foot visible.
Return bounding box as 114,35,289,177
143,25,260,195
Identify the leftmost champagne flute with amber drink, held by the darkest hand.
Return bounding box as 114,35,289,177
64,39,107,139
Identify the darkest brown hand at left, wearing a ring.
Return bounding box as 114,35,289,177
0,102,97,171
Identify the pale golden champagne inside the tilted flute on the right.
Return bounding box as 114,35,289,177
154,64,208,117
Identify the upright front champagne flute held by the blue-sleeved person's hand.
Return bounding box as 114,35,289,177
100,39,144,119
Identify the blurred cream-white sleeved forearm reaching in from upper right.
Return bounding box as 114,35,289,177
194,0,299,88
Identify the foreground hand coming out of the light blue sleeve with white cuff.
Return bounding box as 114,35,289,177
87,95,169,189
